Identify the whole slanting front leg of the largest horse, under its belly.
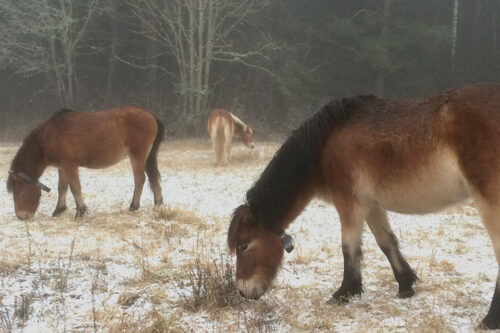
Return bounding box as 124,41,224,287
366,207,418,298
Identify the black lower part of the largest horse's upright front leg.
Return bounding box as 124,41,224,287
327,245,363,304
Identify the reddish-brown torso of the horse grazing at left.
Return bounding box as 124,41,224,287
43,107,158,168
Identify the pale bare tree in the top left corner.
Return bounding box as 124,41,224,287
0,0,101,107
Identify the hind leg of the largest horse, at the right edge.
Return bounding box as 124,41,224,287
473,195,500,329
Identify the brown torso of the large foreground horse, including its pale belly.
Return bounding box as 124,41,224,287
319,85,500,214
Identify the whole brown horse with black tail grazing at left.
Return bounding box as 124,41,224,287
7,107,164,219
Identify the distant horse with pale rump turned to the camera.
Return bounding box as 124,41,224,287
208,109,254,165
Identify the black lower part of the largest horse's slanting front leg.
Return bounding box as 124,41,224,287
380,233,418,298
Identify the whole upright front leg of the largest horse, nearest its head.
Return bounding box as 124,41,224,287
327,201,364,304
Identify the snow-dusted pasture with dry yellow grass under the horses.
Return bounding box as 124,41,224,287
0,138,497,332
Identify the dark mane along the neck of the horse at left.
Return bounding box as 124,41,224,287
7,109,74,193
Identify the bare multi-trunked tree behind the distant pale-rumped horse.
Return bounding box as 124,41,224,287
127,0,273,124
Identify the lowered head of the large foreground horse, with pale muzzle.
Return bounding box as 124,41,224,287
227,205,293,299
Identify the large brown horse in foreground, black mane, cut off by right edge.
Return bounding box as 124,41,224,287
228,85,500,329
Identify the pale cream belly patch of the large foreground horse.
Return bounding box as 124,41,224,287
369,152,469,214
